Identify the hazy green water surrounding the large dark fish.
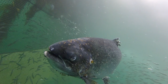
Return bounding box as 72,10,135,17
0,0,168,84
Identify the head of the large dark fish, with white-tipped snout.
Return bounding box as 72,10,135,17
44,42,91,76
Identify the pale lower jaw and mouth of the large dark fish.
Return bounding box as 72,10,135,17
44,51,74,75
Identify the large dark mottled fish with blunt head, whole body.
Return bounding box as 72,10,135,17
44,38,121,84
